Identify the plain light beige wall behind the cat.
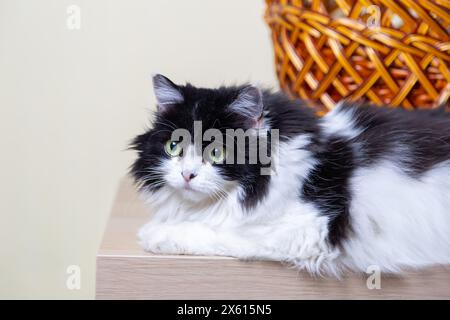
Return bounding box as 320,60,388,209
0,0,276,298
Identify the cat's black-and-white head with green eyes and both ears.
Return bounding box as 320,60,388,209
131,75,263,202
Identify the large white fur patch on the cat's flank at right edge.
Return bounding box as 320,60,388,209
341,161,450,272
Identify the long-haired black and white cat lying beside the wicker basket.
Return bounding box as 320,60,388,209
131,75,450,275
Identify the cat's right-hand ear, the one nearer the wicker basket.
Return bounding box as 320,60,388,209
229,85,263,126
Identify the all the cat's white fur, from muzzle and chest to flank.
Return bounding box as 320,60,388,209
139,109,450,275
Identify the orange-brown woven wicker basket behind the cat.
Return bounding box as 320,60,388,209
265,0,450,112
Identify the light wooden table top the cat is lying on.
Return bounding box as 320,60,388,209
96,178,450,299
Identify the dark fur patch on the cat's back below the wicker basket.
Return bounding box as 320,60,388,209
345,104,450,178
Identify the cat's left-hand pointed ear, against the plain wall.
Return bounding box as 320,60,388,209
153,74,184,112
